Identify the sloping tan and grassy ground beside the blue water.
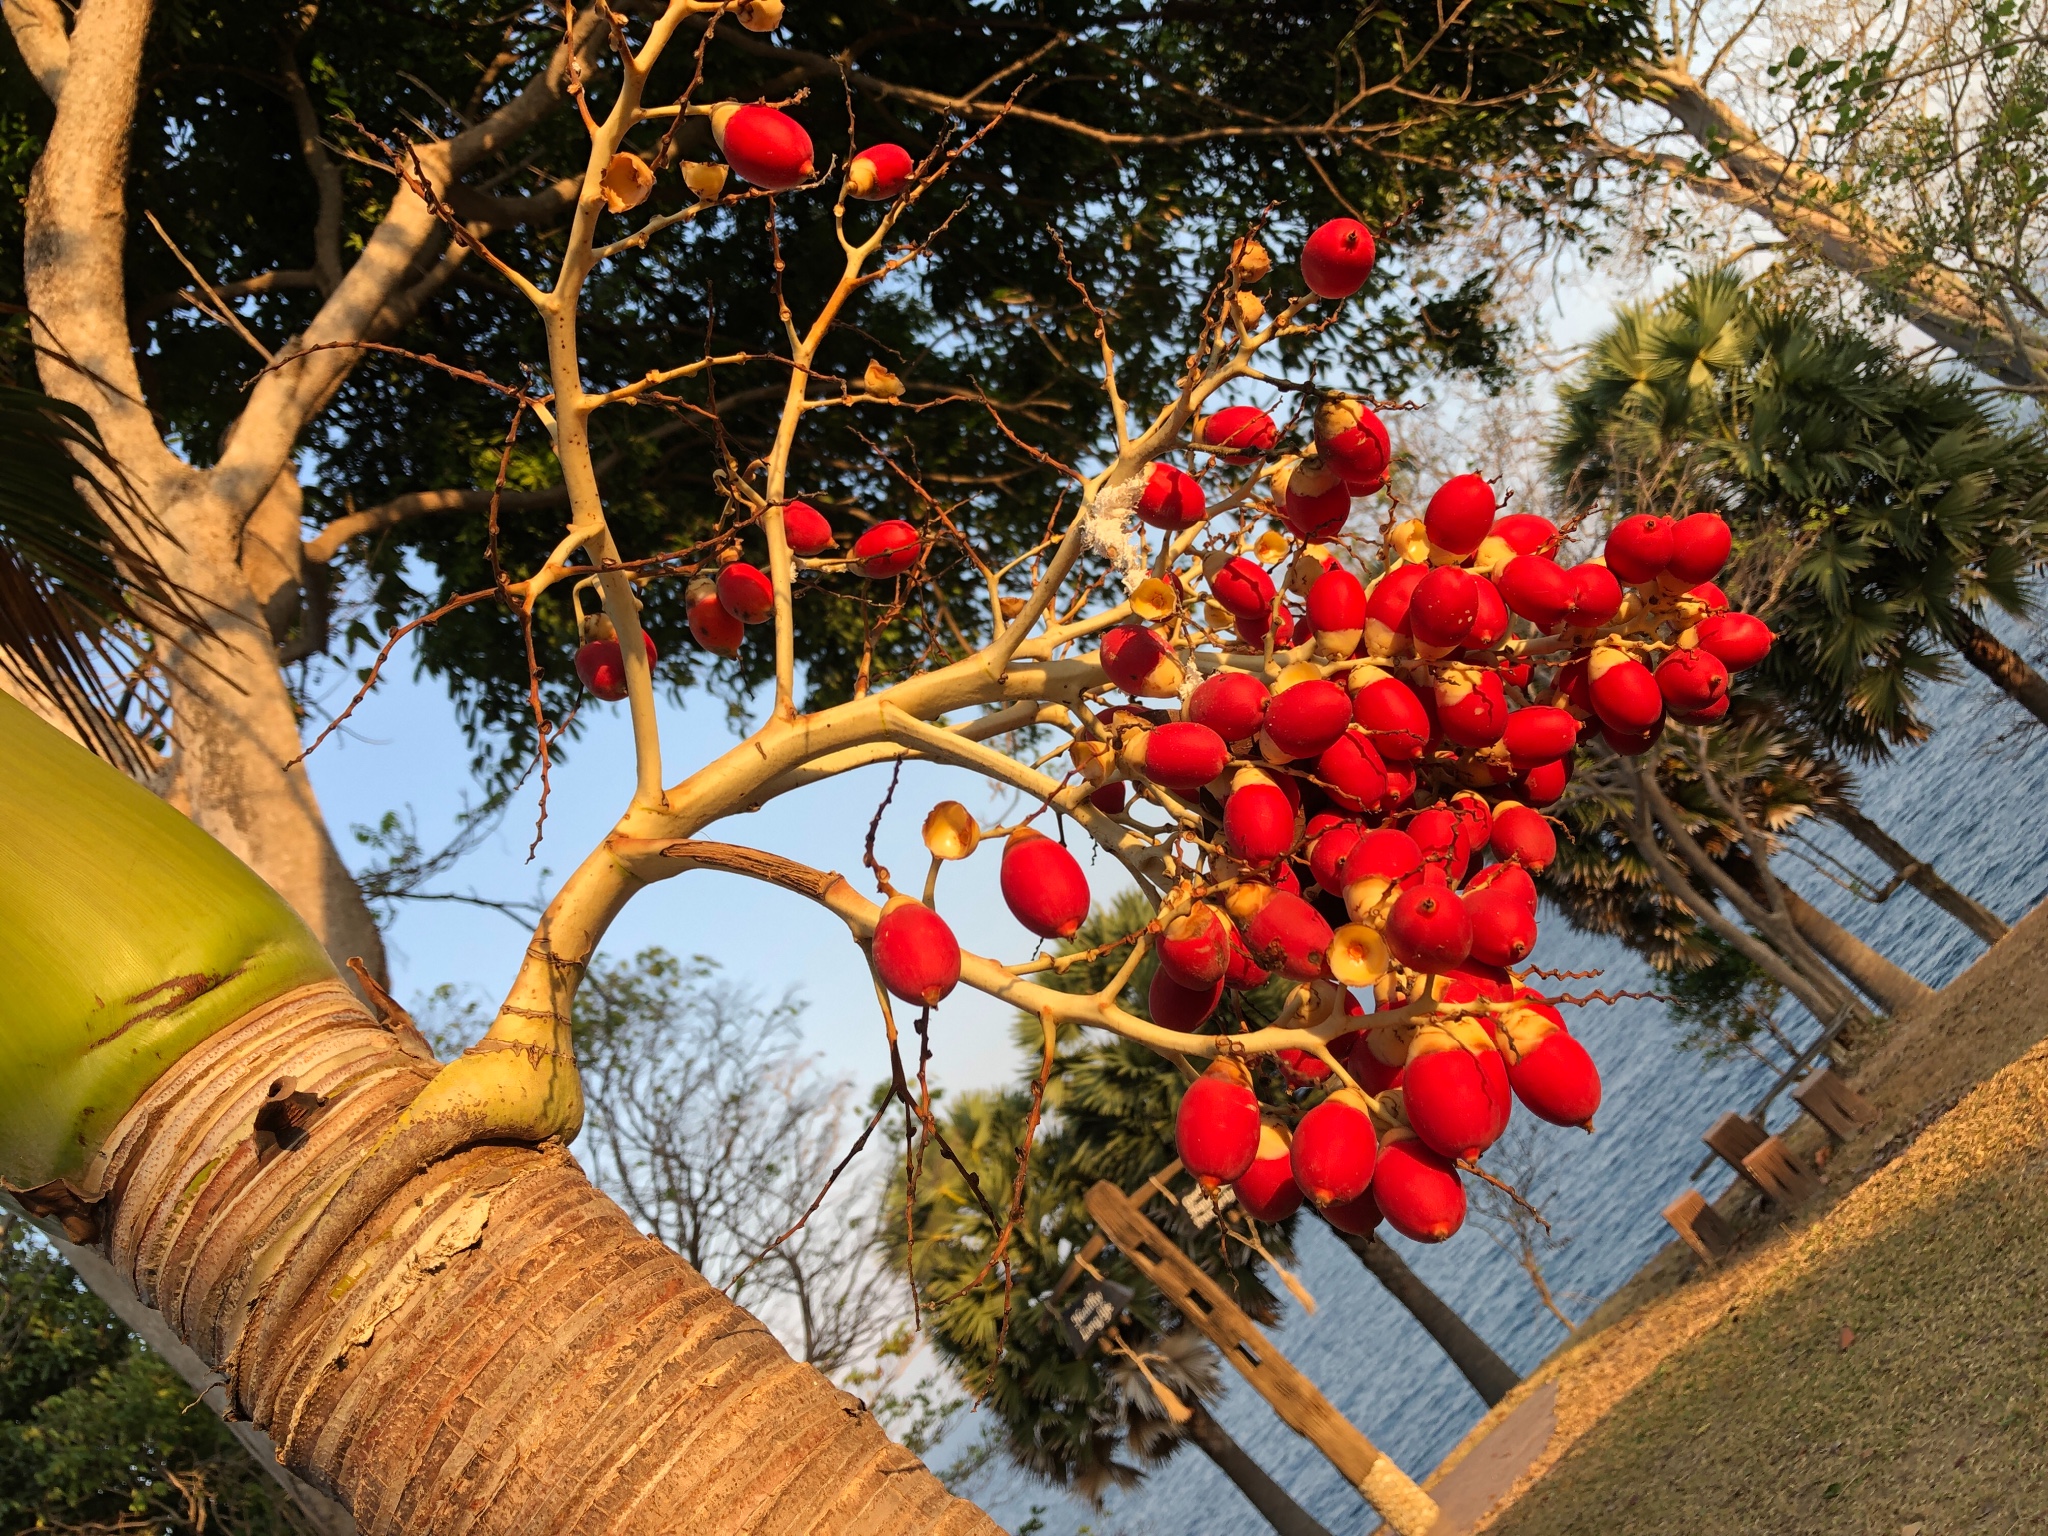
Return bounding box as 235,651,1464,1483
1432,907,2048,1536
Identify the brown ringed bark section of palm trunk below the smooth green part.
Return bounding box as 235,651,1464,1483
83,981,997,1536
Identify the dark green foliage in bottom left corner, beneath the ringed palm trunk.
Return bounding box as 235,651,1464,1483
0,1217,295,1536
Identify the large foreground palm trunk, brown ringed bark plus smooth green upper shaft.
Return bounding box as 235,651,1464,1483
0,700,995,1536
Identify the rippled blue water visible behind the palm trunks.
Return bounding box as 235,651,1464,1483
932,633,2048,1536
